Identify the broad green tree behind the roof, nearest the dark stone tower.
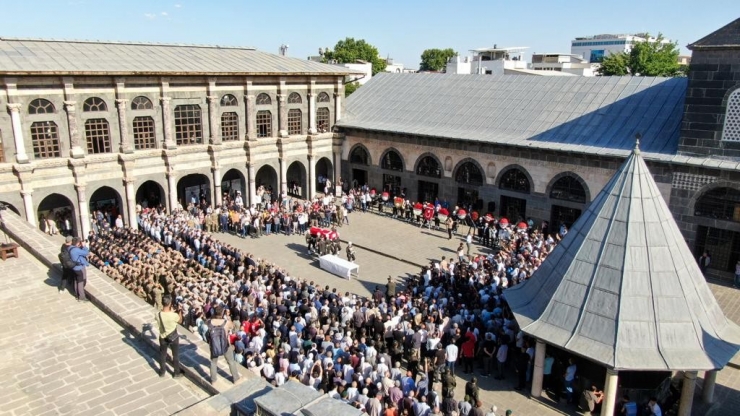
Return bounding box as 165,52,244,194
599,34,685,77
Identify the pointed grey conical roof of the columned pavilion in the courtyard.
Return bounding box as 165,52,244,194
504,145,740,370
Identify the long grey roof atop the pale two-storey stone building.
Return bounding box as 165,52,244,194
0,38,355,75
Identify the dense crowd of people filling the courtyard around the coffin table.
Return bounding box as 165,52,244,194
66,184,608,416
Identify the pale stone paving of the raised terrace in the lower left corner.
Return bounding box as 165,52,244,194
0,244,209,416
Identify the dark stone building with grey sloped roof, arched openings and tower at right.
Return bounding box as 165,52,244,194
338,19,740,276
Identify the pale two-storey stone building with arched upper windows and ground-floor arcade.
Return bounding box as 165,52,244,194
0,38,351,239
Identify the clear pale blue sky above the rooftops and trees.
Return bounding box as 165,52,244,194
0,0,740,68
